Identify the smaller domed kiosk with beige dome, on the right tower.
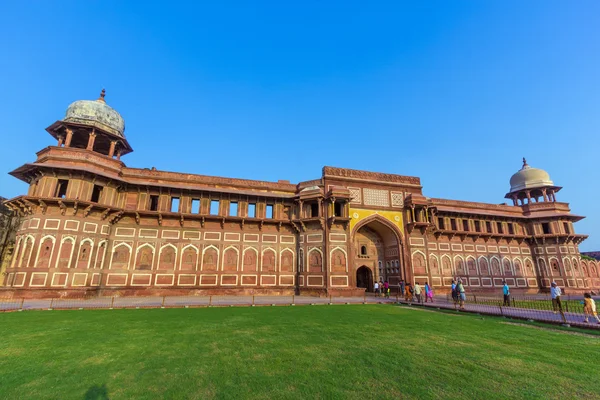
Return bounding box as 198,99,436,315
505,158,561,205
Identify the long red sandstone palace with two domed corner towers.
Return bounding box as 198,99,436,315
1,91,600,296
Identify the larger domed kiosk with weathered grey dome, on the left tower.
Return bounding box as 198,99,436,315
46,89,133,159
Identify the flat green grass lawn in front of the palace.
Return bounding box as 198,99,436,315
0,305,600,399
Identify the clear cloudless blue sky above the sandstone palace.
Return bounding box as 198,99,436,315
0,0,600,250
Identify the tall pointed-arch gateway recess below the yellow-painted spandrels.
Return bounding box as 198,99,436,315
352,214,406,291
